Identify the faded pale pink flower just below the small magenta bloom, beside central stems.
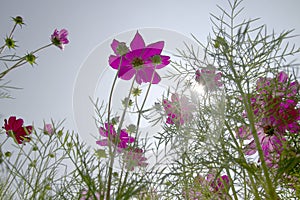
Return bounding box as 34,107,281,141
123,148,148,171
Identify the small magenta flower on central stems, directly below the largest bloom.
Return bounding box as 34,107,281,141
96,123,134,150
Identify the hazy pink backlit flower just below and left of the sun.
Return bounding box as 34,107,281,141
163,93,195,126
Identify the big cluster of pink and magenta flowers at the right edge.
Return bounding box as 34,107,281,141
238,71,300,167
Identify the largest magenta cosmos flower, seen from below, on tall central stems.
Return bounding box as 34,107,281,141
109,32,170,84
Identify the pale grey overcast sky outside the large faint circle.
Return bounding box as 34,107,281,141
0,0,300,145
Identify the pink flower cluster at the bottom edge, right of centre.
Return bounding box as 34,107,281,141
183,174,230,200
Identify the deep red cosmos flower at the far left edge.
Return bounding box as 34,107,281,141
2,116,32,144
